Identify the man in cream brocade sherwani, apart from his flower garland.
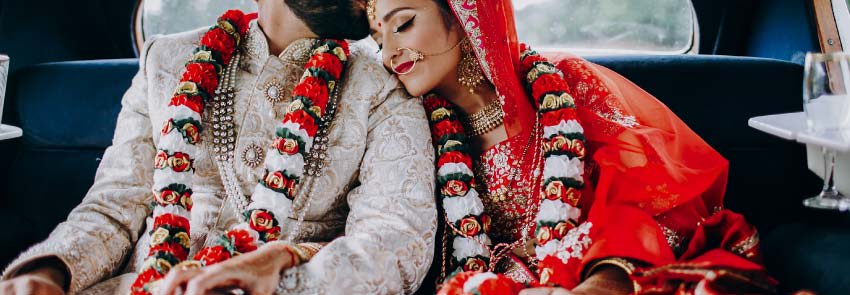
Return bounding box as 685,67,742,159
0,0,437,294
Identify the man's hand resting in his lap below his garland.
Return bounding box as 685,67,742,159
157,243,295,295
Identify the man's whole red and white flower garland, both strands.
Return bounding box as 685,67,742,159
126,10,350,294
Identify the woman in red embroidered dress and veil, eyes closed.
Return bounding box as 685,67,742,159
367,0,775,294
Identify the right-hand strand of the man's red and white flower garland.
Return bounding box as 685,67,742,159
195,39,350,266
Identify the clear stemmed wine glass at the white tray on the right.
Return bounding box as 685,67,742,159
803,53,850,209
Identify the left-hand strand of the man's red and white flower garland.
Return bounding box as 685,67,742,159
131,10,248,294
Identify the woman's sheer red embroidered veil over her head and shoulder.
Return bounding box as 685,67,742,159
447,0,763,288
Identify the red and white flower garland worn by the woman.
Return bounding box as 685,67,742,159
424,44,586,294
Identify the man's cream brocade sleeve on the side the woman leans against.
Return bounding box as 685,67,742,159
282,74,437,294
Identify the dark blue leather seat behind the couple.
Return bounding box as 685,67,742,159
0,55,850,293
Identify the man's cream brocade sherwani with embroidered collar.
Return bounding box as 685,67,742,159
4,22,437,294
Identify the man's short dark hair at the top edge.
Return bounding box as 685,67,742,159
284,0,369,40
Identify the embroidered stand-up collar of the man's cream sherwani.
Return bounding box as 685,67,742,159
244,20,319,64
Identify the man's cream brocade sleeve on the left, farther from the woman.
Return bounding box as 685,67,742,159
3,35,161,293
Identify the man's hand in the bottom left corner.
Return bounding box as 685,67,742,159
0,267,65,295
